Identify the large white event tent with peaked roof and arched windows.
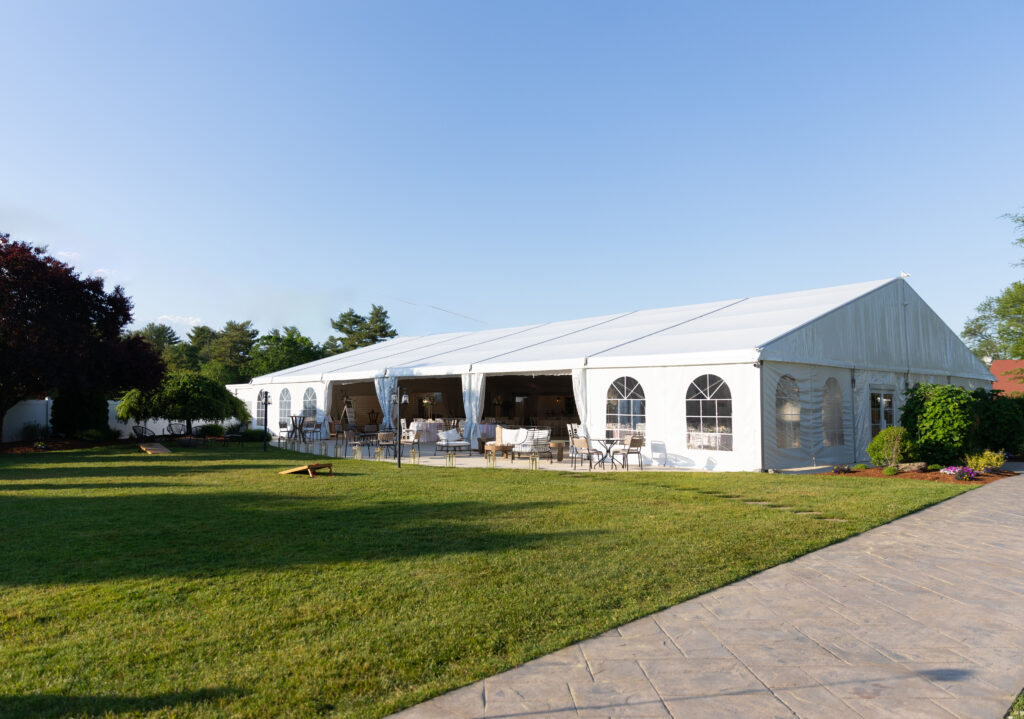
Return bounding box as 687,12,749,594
229,278,994,470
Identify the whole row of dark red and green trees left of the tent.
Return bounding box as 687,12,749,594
0,232,396,439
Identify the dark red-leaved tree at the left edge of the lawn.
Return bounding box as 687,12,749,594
0,234,164,442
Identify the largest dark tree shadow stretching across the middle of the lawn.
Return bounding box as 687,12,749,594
0,493,582,586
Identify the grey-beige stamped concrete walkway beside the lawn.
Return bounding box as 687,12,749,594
395,475,1024,719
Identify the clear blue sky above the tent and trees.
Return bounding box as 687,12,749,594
0,0,1024,339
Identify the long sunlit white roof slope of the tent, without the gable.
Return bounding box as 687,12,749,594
253,280,958,383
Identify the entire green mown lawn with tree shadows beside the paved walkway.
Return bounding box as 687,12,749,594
0,447,968,717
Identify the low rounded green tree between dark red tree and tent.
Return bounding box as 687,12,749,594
118,370,250,434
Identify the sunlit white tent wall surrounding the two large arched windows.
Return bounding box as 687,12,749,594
587,364,761,471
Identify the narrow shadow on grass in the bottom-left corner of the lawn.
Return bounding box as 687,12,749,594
0,689,243,717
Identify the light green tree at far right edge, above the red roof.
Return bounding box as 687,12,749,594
961,214,1024,360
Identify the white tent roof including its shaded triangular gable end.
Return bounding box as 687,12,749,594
253,279,991,384
